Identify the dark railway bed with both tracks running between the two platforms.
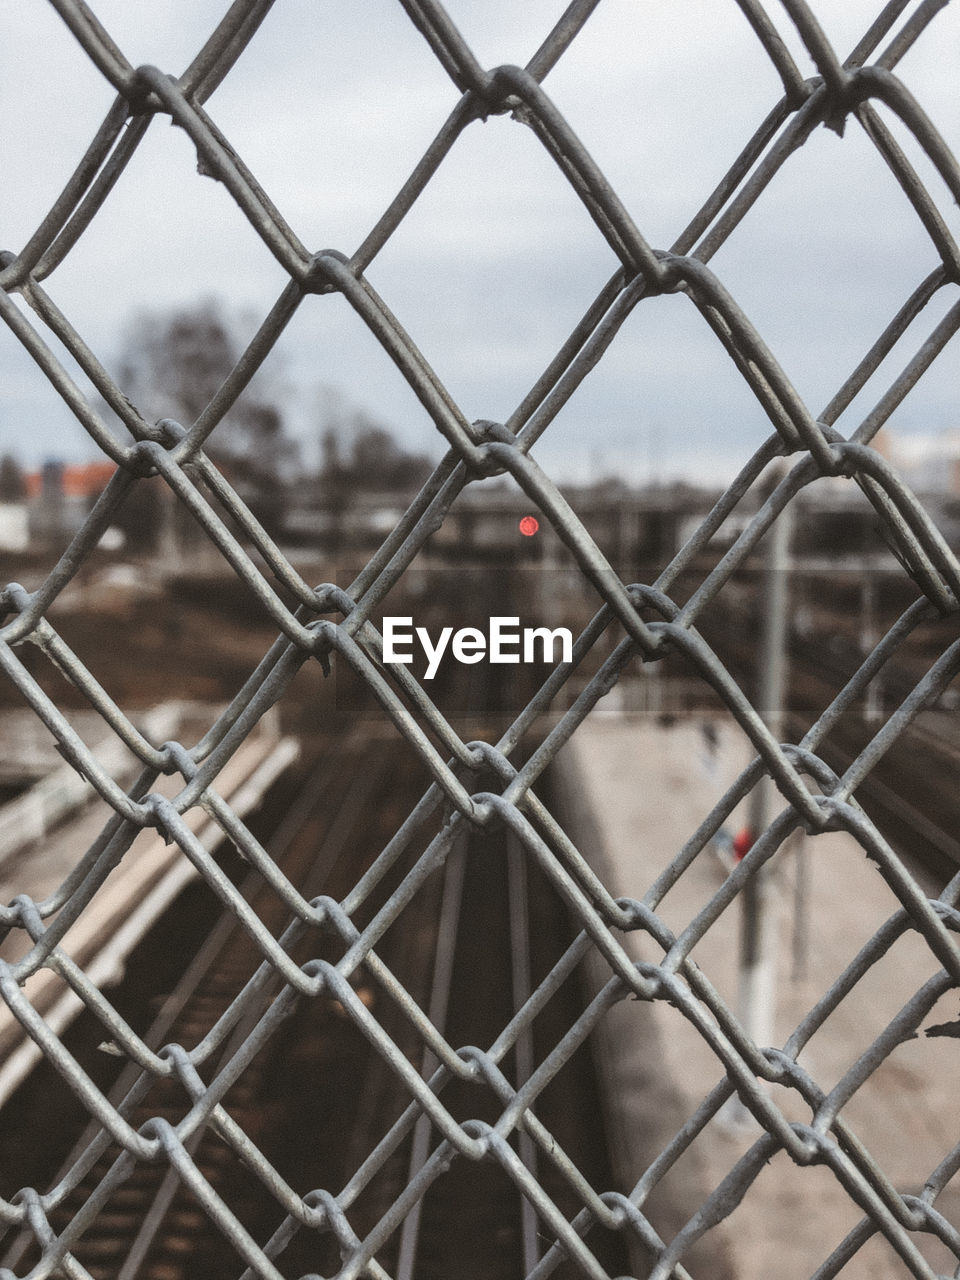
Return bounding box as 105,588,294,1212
0,578,627,1280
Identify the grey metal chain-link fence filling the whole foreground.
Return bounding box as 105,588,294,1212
0,0,960,1280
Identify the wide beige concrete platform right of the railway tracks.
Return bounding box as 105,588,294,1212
561,704,960,1280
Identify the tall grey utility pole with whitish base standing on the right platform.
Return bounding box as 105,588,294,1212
737,494,794,1047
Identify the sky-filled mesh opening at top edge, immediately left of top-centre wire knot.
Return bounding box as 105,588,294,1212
211,5,457,244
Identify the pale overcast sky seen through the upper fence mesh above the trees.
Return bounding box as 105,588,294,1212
0,0,960,480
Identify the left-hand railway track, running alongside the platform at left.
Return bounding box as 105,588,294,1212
5,750,407,1280
